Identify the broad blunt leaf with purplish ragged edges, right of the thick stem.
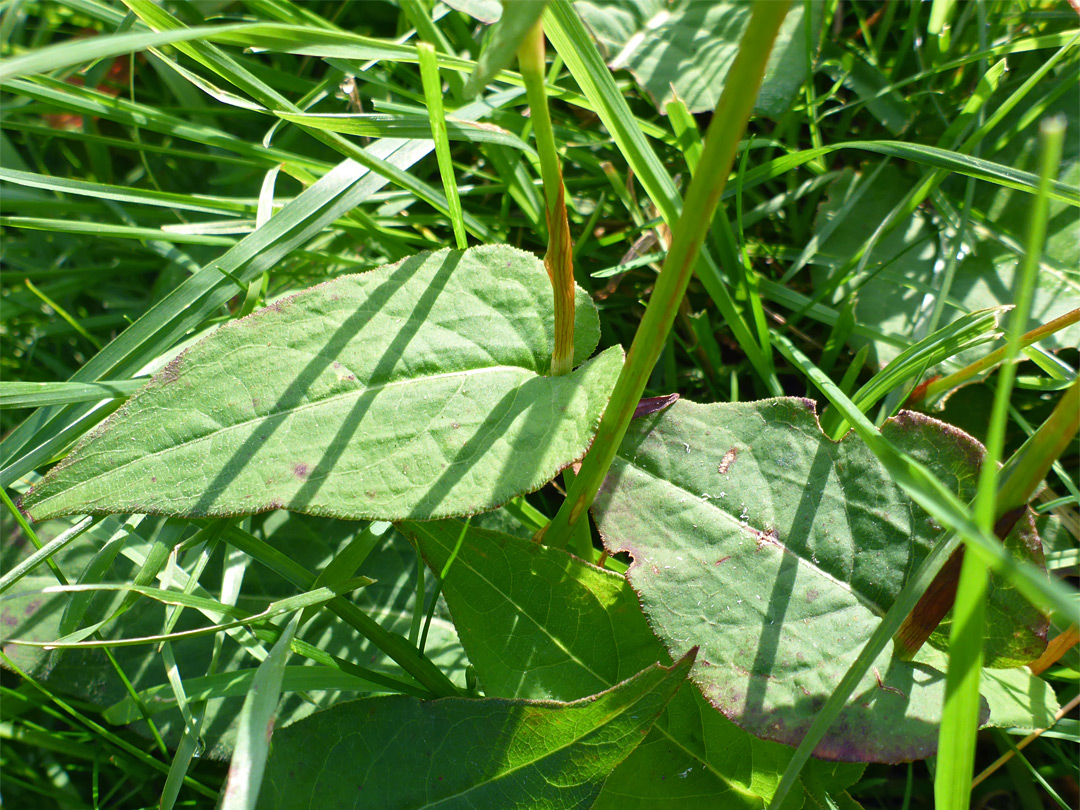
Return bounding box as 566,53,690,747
594,399,1045,761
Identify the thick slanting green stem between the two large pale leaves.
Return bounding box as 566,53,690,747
544,0,789,548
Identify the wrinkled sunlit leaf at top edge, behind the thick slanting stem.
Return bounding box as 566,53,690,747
573,0,822,118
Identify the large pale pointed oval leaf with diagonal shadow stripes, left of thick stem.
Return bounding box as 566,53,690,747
22,245,622,521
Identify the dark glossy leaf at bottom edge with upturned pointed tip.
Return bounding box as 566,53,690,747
252,653,693,810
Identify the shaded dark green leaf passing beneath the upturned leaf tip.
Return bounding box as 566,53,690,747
402,521,861,810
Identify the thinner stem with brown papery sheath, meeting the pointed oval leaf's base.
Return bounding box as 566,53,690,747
517,21,573,376
